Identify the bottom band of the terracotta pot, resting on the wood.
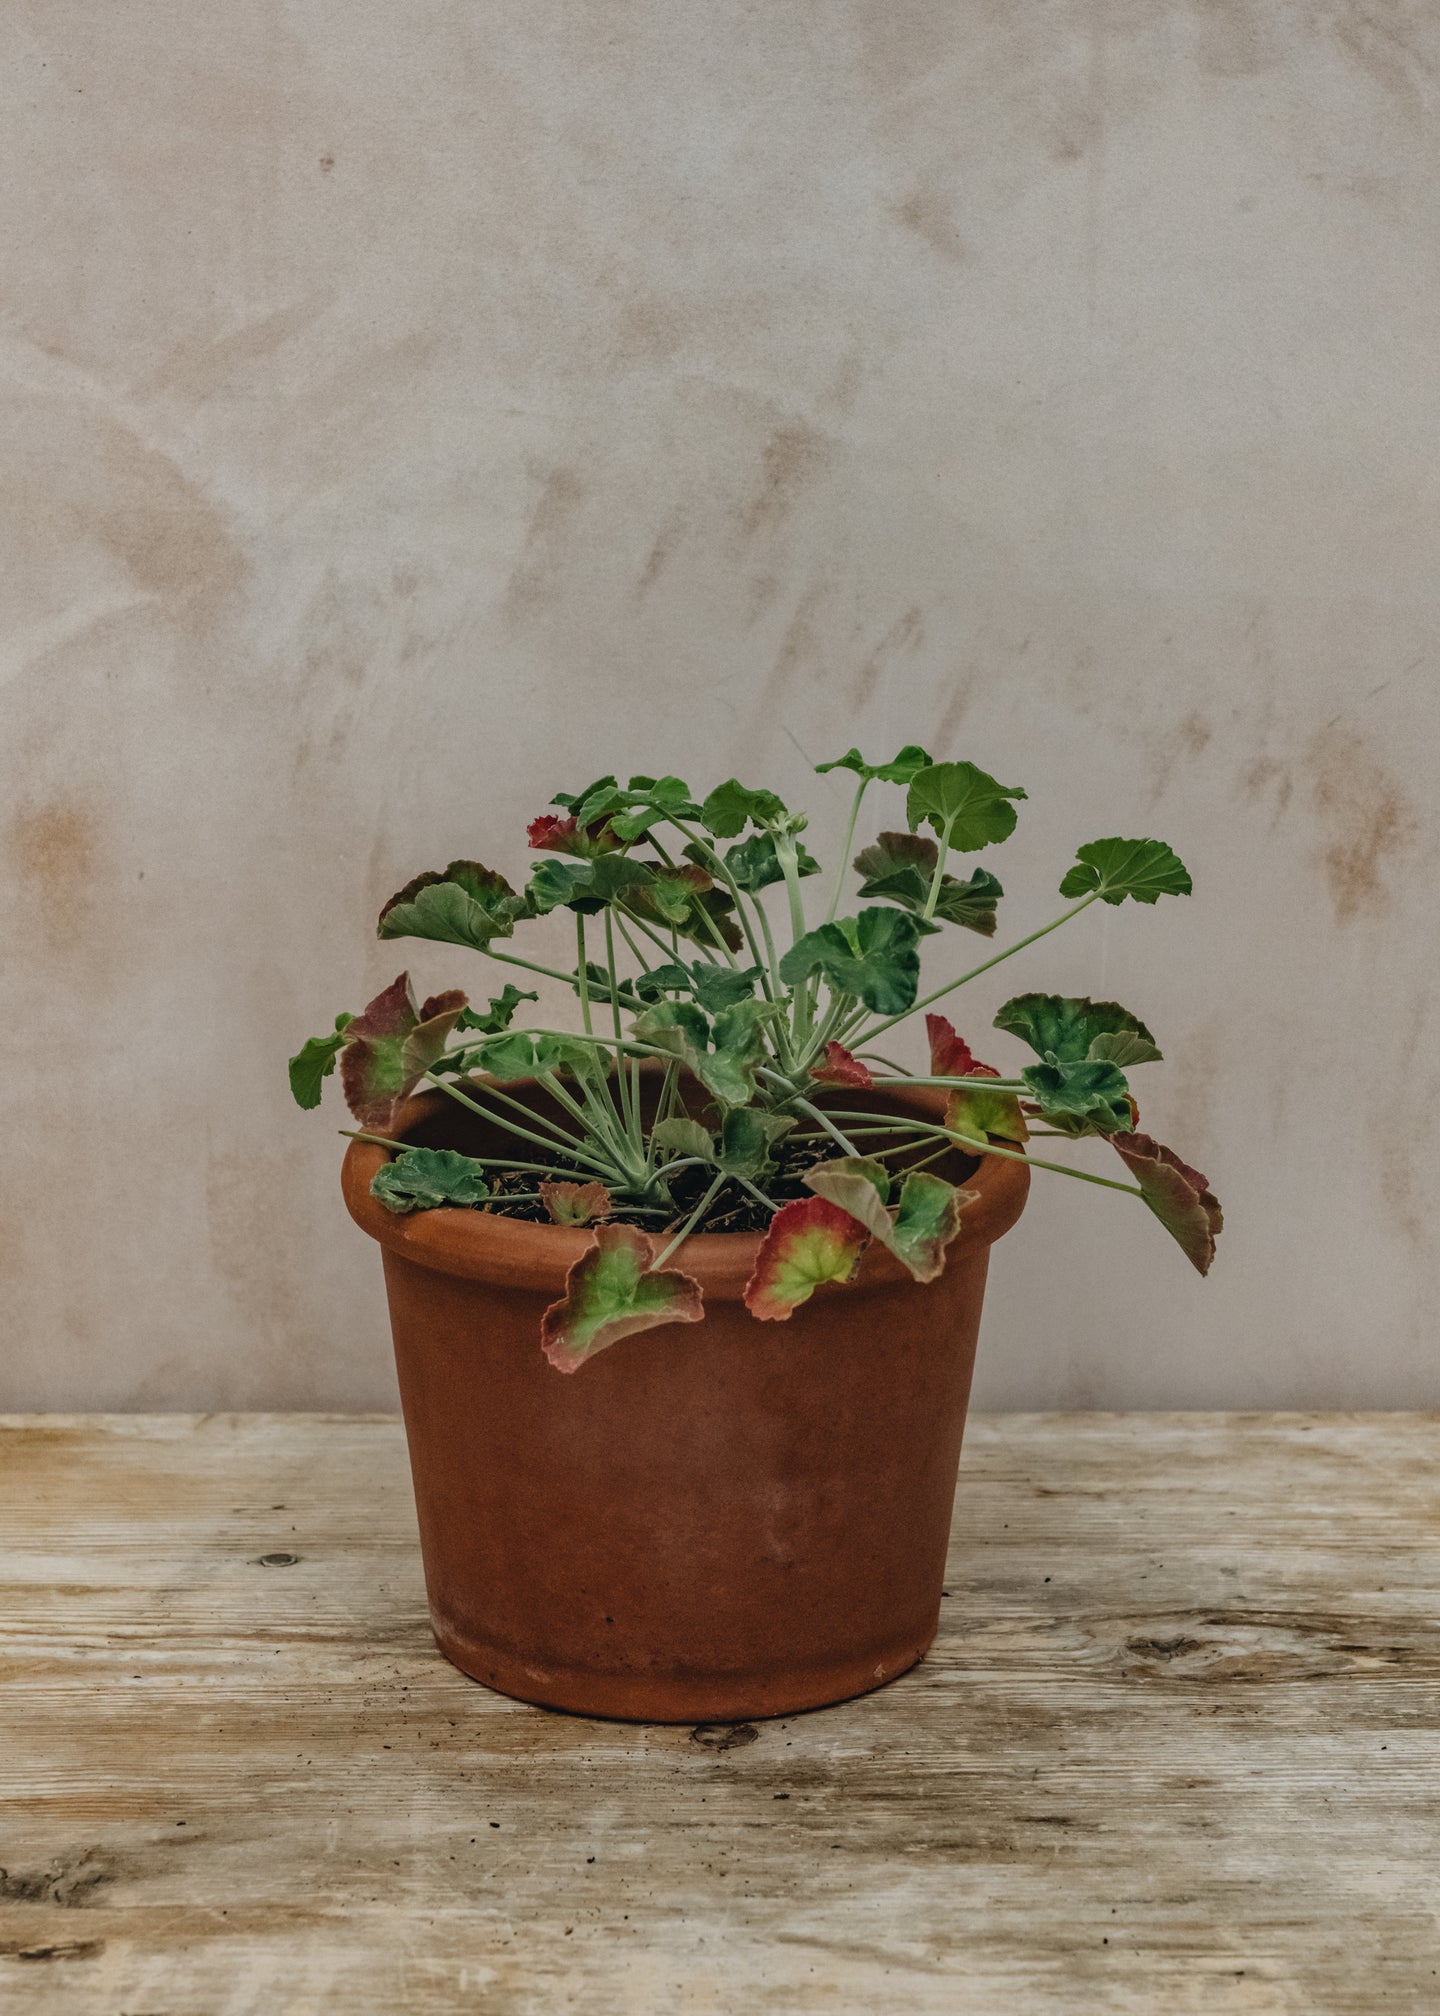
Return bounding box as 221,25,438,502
432,1619,936,1724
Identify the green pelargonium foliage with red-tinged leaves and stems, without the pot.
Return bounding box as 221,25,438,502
290,746,1220,1371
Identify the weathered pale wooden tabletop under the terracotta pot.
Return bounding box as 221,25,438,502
0,1413,1440,2016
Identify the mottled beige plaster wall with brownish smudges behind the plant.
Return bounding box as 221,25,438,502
0,0,1440,1407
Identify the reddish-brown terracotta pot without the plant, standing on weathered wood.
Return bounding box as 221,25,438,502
345,1087,1029,1722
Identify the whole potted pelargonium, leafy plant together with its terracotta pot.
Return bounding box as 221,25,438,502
290,746,1220,1722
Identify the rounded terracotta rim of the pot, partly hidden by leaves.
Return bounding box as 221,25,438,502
341,1081,1031,1302
